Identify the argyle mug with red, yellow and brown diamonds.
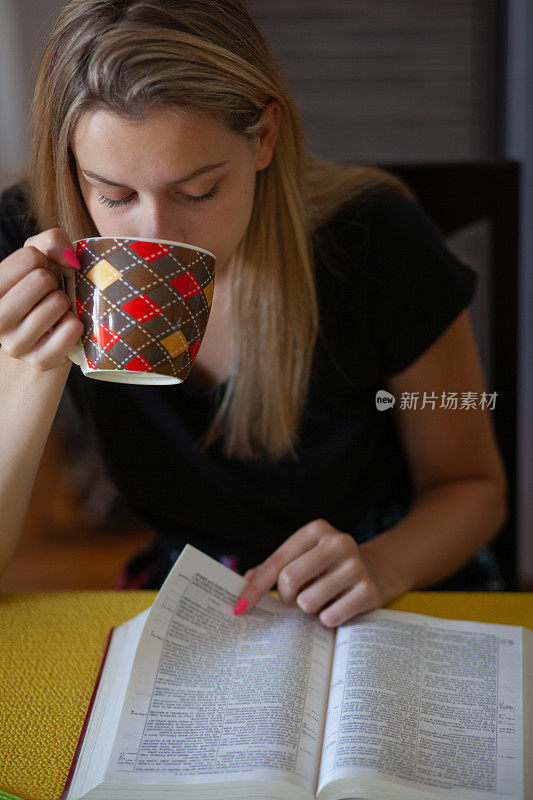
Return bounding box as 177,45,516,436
67,236,215,384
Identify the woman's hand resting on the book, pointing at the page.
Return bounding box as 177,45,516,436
236,519,390,628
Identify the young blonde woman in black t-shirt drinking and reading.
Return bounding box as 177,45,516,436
0,0,506,626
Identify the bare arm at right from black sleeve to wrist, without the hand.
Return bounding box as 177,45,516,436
361,310,507,596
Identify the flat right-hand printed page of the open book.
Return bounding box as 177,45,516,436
319,609,524,800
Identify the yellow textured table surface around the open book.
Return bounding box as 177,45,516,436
0,591,533,800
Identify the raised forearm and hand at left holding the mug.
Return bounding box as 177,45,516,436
0,228,83,572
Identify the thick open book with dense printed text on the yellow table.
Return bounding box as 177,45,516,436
62,545,533,800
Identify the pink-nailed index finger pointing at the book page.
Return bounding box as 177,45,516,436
233,523,318,615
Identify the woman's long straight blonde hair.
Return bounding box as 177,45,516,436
25,0,414,461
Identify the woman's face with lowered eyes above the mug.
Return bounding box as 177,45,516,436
72,102,281,276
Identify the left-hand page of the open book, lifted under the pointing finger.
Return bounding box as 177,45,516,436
105,545,334,797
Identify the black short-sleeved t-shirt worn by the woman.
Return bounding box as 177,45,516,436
0,187,478,563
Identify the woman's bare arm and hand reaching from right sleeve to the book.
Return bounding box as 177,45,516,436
237,310,506,626
